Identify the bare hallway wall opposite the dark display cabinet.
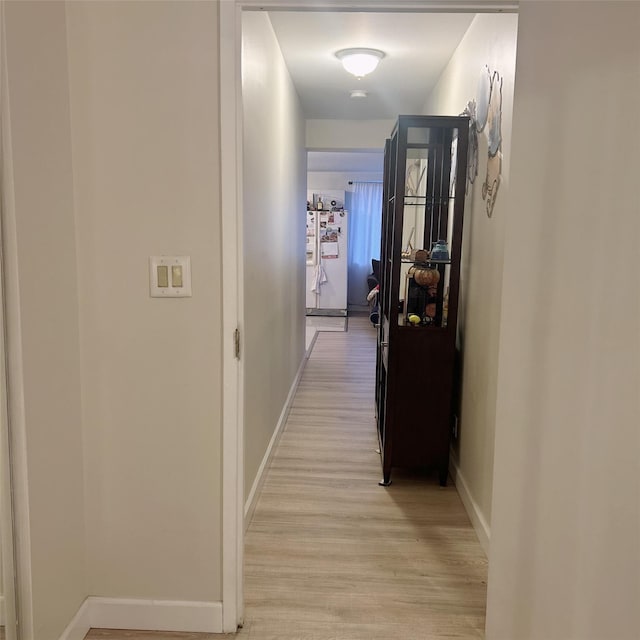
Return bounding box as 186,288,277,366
242,12,307,498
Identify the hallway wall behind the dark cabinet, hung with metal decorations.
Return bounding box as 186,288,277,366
424,14,518,552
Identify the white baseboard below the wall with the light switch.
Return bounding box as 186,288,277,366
60,597,222,640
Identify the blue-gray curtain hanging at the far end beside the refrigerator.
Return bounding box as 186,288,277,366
345,182,382,306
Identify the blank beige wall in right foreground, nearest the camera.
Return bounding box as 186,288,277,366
487,0,640,640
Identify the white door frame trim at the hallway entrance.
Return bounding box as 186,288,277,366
218,0,519,632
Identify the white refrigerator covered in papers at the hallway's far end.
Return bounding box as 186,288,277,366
306,196,349,316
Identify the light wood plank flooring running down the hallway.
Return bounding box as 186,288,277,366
87,317,487,640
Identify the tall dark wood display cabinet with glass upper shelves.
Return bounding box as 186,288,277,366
376,116,469,486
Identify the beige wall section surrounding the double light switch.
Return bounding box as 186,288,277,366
65,1,221,604
